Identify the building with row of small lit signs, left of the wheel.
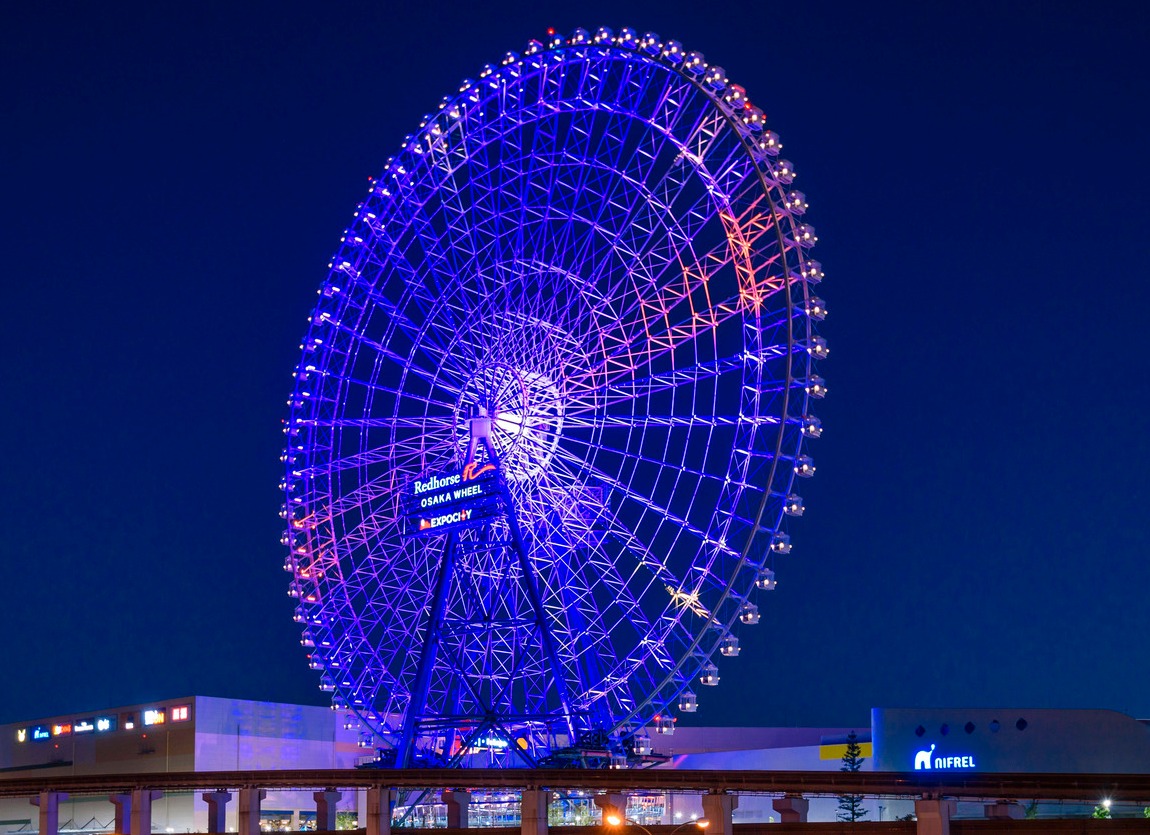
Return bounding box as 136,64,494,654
0,696,366,835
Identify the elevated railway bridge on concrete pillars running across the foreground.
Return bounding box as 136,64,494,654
0,768,1150,835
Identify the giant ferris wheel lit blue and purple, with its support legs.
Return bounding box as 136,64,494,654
283,28,827,765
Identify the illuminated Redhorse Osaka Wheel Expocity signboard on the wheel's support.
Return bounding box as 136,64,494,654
401,462,503,536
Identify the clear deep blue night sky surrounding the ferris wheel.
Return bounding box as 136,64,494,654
0,0,1150,726
